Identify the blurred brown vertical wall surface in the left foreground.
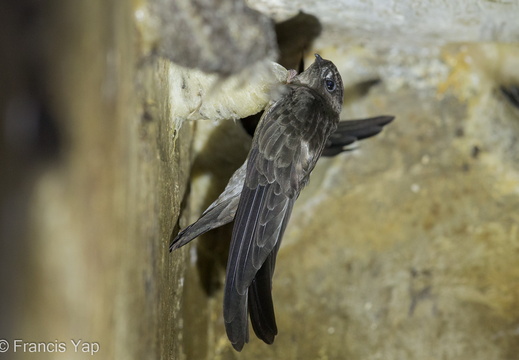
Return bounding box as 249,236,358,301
0,1,192,359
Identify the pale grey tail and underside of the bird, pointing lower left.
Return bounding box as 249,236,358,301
169,161,247,251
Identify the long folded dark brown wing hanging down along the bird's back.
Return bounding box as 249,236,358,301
224,86,338,350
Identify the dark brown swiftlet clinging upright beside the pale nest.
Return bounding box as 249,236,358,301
170,54,393,351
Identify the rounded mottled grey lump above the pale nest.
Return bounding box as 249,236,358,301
144,0,277,77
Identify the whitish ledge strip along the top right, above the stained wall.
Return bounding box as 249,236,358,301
248,0,519,47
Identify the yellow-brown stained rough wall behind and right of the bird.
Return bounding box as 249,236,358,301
200,43,519,359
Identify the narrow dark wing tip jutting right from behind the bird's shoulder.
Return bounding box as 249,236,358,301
323,116,394,156
